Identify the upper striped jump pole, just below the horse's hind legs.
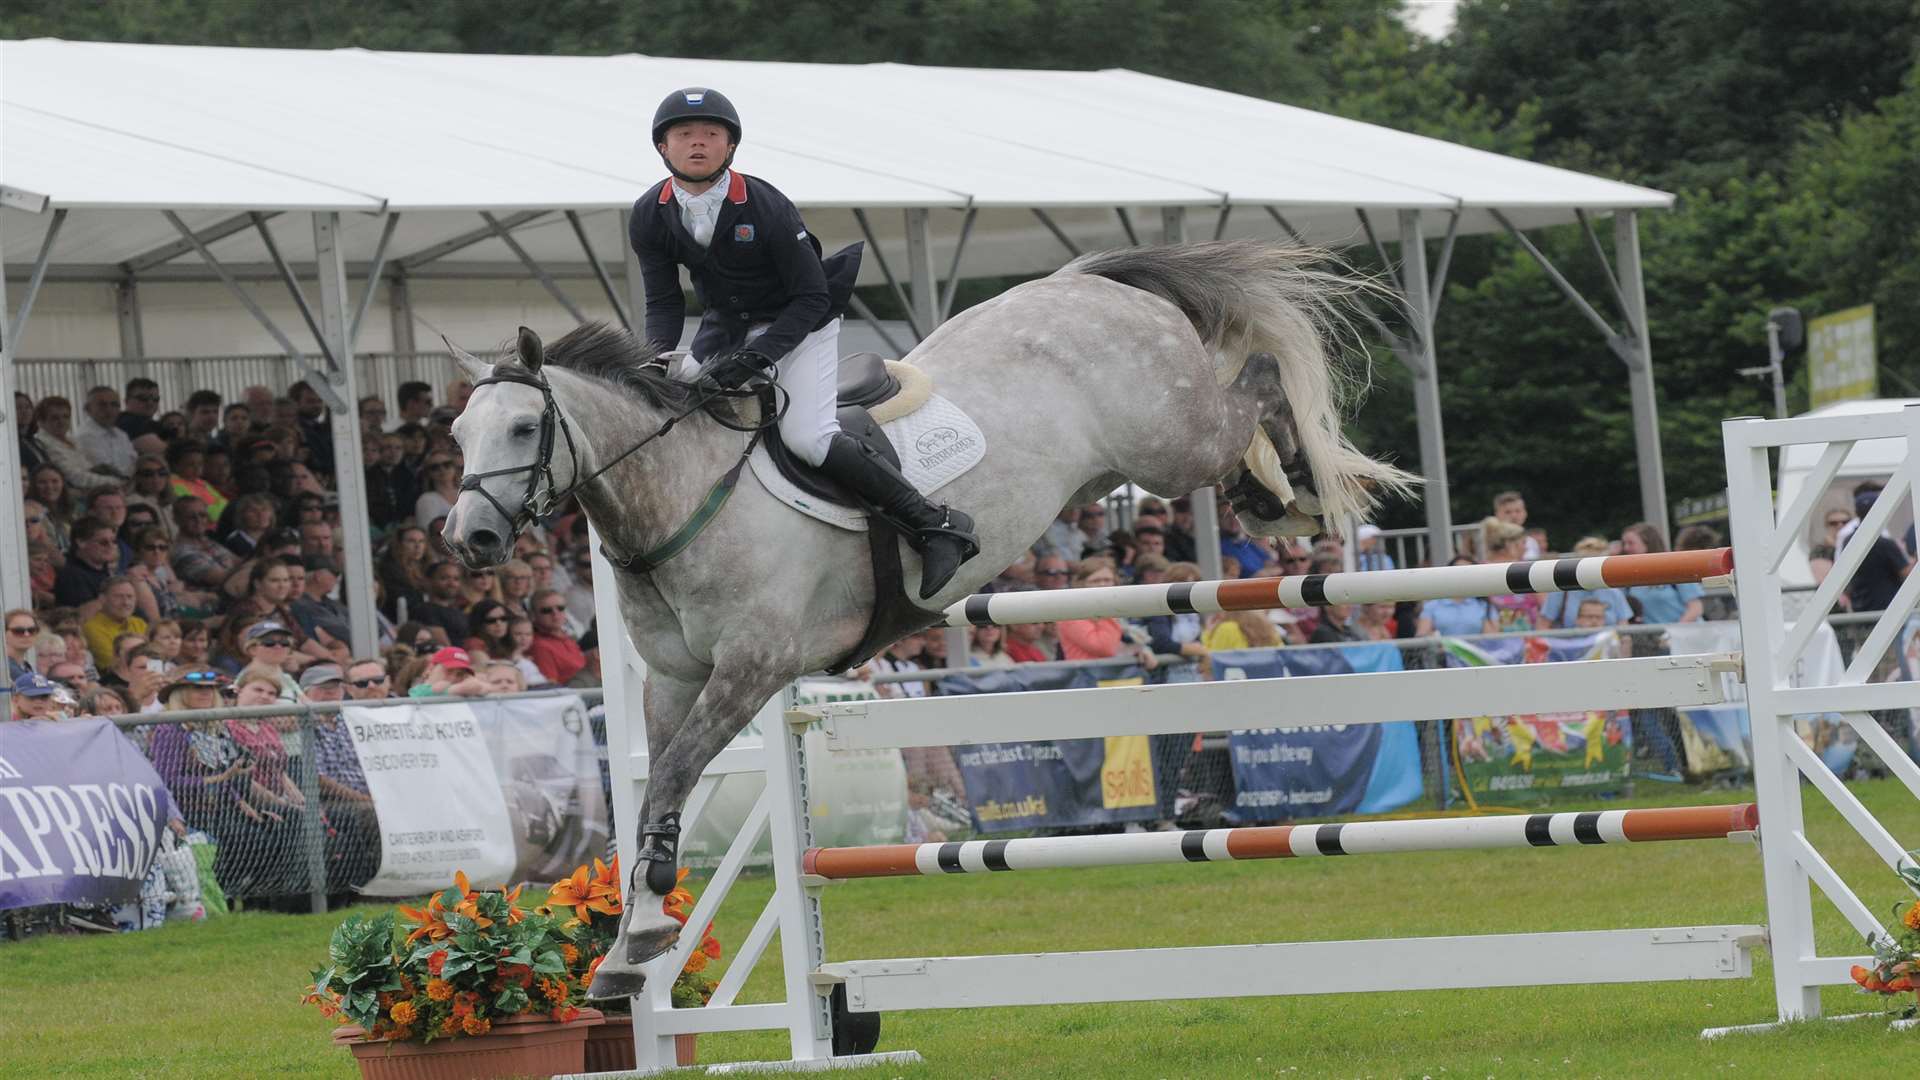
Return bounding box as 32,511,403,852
947,548,1734,626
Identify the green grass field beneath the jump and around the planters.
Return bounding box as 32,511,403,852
0,782,1920,1080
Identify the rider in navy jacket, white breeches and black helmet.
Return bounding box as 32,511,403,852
628,86,979,600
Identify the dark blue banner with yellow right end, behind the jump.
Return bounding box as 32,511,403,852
941,669,1160,832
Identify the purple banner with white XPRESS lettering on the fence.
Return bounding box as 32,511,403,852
0,719,179,909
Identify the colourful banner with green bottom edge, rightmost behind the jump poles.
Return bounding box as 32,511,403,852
1442,630,1634,801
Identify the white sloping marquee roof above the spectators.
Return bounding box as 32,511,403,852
0,40,1672,275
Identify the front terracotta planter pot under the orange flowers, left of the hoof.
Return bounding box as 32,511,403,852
334,1009,599,1080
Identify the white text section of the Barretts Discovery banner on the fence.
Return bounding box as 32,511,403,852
340,703,518,896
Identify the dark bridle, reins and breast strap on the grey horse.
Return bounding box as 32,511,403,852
461,369,785,575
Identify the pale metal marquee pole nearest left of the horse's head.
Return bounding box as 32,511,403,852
313,211,378,645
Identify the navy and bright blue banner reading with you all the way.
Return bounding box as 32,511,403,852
1213,642,1421,822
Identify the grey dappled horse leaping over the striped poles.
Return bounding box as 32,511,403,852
445,240,1407,997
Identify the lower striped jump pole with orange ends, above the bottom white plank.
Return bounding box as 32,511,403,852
803,803,1761,880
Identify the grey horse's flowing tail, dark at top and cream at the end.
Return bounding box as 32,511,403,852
1060,240,1419,528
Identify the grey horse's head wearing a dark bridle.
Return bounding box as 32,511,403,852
442,327,580,567
